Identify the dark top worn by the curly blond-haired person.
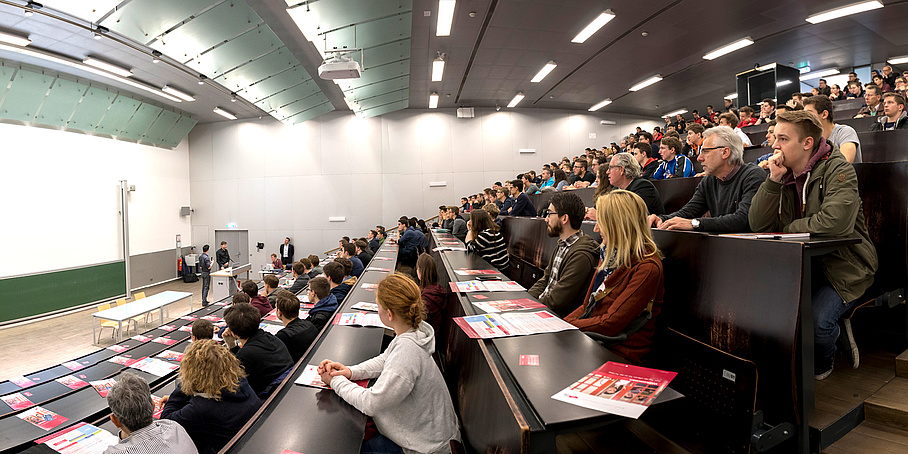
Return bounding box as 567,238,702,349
161,378,262,454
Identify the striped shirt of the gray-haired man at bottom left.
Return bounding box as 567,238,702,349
104,419,199,454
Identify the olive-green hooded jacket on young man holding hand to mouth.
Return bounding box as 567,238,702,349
748,138,877,303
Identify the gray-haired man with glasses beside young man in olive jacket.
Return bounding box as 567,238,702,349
649,126,766,233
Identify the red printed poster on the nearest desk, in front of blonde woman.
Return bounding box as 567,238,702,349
552,361,678,418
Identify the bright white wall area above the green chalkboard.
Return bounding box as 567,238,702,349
0,123,191,276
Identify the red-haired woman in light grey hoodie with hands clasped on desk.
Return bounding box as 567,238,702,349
318,273,460,453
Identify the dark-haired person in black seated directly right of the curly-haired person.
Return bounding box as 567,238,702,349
222,304,293,394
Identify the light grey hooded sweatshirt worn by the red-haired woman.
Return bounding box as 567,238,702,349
330,322,460,454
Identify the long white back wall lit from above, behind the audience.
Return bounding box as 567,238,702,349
189,109,663,269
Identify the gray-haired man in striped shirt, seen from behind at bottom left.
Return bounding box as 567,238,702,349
104,372,198,454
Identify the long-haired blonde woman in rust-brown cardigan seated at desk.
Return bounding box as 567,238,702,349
564,189,665,364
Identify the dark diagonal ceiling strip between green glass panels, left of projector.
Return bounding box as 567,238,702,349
247,0,350,111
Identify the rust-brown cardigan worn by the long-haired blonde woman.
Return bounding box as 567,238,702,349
564,256,665,364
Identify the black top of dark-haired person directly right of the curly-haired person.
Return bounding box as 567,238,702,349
230,329,293,394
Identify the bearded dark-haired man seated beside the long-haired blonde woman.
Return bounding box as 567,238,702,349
527,192,608,317
